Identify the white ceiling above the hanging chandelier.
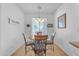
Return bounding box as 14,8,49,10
17,3,61,14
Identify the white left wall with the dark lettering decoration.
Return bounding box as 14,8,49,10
0,3,24,55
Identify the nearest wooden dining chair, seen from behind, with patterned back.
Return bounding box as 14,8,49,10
34,35,48,56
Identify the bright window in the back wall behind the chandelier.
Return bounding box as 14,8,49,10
32,18,47,35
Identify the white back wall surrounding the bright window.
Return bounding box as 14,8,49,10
25,13,54,39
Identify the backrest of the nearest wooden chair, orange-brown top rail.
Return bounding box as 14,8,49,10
35,35,48,49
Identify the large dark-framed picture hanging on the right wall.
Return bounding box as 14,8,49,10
58,13,66,29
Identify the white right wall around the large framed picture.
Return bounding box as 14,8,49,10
54,3,79,55
